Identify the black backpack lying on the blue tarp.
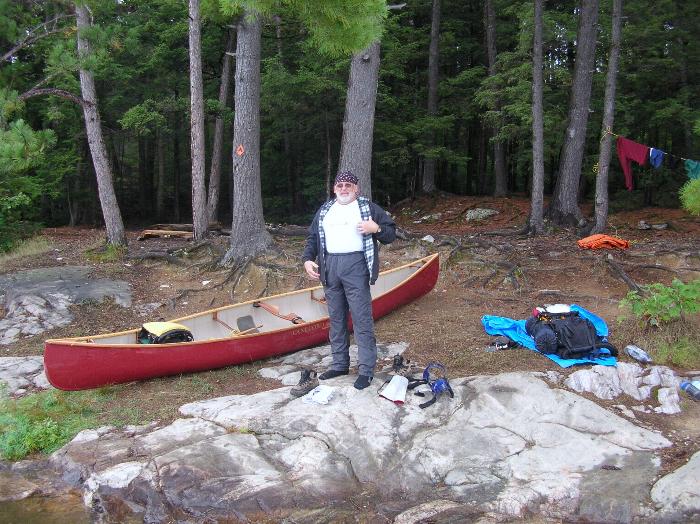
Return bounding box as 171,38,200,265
525,311,617,359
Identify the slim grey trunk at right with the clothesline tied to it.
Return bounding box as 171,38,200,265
591,0,622,233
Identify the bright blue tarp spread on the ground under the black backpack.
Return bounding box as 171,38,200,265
481,304,617,368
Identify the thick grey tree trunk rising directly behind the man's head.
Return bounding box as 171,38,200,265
338,42,379,199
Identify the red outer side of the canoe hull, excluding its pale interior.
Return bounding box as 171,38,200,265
44,256,439,391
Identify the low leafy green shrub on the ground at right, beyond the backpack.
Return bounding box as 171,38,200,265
620,279,700,327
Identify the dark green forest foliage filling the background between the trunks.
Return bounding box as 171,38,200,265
0,0,700,227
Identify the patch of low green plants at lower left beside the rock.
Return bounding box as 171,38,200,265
0,390,95,460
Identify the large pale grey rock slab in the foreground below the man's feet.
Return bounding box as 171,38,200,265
46,373,700,522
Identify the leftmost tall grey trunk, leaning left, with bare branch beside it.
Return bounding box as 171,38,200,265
75,4,126,246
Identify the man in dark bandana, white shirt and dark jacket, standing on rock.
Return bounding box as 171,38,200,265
302,171,396,389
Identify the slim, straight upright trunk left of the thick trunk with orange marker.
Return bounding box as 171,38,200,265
189,0,209,240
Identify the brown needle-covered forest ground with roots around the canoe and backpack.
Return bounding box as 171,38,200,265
0,194,700,476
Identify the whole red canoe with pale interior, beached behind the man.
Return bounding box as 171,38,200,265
44,254,440,391
